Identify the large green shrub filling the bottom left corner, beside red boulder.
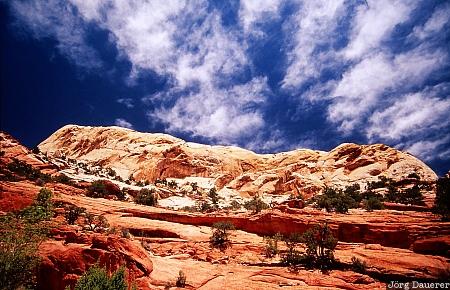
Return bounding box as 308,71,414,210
0,214,48,290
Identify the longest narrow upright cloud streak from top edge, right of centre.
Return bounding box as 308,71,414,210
282,0,344,89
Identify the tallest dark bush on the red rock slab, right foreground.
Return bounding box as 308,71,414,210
302,224,337,270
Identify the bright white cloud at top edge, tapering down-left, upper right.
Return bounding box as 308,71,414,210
343,0,418,59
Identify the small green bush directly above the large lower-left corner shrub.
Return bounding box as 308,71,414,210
19,188,54,223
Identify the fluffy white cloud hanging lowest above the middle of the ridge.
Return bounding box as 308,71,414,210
149,78,268,143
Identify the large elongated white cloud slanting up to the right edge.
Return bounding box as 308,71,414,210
328,46,447,133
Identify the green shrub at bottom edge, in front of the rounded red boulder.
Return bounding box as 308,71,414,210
74,265,129,290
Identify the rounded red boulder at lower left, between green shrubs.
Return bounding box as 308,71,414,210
38,226,153,290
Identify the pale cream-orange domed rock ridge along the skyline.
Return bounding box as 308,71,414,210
38,125,437,197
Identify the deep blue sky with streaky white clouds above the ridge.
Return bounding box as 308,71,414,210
0,0,450,174
